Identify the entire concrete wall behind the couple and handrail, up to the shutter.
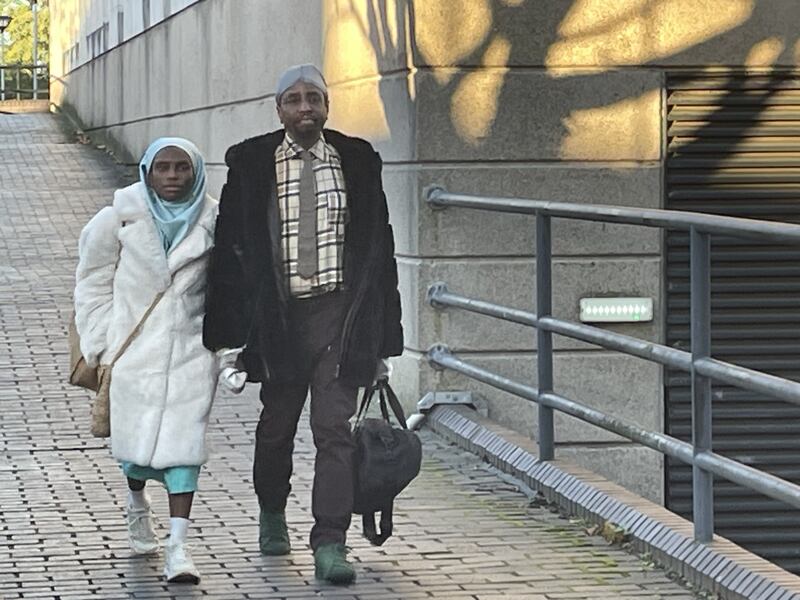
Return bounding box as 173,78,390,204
52,0,800,500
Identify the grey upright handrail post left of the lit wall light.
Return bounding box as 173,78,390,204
536,213,555,460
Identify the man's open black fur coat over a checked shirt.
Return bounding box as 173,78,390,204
203,129,403,386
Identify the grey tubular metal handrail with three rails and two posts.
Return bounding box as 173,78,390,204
424,186,800,543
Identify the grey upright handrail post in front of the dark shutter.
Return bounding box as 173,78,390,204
690,227,714,543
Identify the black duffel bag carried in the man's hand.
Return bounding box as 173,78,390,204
353,379,422,546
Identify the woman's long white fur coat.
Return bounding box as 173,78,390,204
75,182,218,469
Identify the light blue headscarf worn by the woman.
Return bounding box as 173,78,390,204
139,137,206,253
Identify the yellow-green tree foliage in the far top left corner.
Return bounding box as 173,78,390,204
0,0,50,64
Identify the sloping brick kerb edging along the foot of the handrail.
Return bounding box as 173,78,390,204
425,406,800,600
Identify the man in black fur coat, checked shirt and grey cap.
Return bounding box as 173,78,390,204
204,64,403,583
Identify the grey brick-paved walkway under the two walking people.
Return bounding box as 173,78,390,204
0,115,695,600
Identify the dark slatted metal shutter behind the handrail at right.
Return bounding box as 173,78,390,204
665,73,800,573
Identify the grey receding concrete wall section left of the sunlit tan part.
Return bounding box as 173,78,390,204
51,0,322,193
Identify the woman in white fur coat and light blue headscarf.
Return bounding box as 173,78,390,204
75,138,219,583
